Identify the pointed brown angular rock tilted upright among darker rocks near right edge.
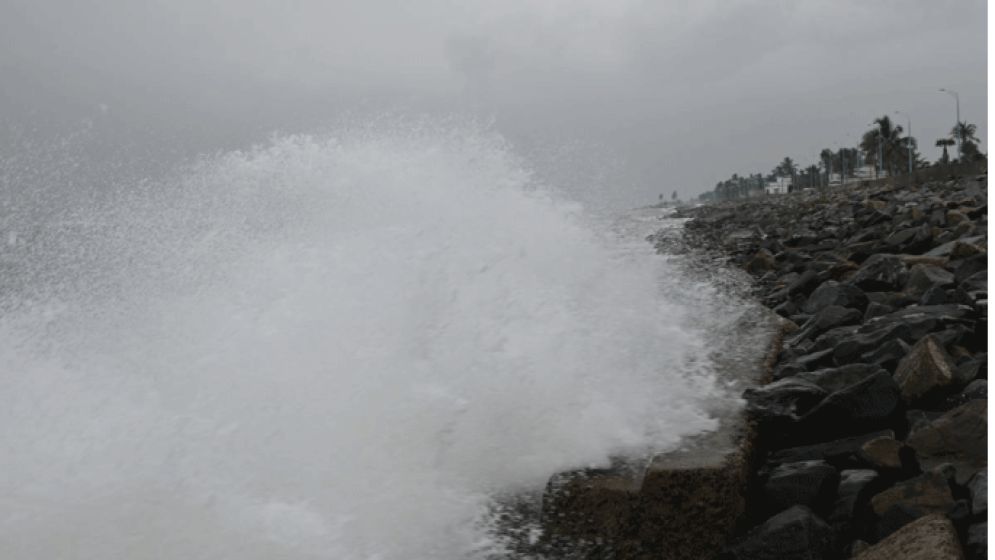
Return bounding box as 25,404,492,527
895,336,956,404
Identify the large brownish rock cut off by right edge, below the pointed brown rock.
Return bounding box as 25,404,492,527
905,399,988,484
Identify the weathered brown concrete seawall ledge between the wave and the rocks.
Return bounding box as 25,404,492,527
542,307,785,560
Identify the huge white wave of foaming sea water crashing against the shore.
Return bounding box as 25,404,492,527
0,124,740,560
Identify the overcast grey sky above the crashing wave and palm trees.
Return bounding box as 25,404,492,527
0,0,988,205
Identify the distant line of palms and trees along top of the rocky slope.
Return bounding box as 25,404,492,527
699,115,987,200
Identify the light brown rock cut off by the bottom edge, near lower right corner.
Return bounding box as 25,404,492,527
855,515,964,560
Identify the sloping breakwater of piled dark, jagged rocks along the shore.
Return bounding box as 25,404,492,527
658,176,988,560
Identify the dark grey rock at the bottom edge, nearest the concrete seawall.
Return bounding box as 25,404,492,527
730,506,833,560
